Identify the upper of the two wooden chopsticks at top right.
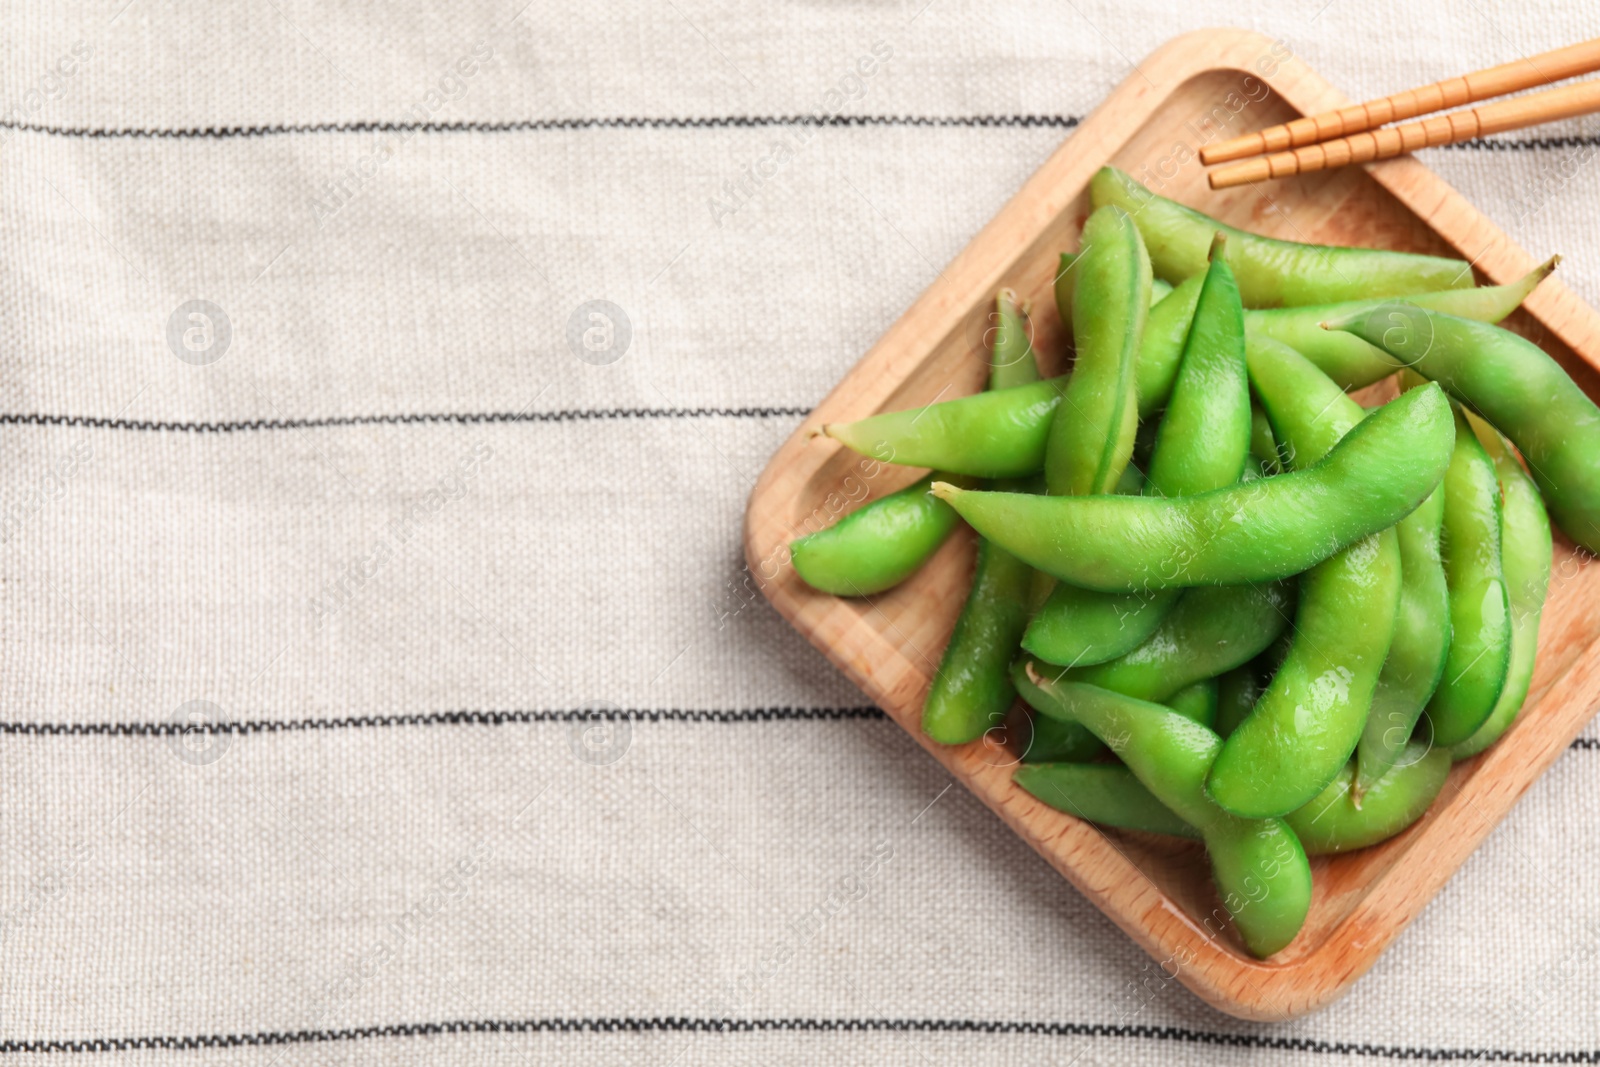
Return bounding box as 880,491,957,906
1200,37,1600,166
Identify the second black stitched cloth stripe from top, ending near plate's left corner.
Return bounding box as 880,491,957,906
0,408,811,434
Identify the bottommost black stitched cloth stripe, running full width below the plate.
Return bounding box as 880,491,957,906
0,1016,1600,1064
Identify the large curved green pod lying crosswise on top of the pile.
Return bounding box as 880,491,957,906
933,389,1454,591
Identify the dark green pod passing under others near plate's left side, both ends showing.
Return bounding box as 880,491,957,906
922,290,1038,745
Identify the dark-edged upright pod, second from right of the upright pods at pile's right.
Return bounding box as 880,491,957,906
1426,411,1510,749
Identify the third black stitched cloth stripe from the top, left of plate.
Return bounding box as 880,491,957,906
0,707,886,737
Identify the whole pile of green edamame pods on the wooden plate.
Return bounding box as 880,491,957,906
790,168,1600,957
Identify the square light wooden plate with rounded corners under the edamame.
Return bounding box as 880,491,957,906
746,30,1600,1019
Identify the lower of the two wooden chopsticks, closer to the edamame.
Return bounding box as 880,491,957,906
1208,78,1600,189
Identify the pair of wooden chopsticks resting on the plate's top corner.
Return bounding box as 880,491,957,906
1200,37,1600,189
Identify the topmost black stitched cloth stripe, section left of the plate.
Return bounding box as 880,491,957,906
0,115,1082,141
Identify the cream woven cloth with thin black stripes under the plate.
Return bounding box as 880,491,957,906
0,0,1600,1067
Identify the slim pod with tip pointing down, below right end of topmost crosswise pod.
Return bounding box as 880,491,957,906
1355,486,1450,797
